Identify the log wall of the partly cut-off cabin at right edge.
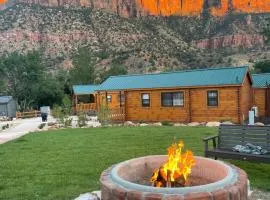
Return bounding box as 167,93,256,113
253,88,266,117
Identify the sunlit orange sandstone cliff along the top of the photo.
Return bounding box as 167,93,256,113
14,0,270,17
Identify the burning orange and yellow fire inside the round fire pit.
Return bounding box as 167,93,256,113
150,141,195,187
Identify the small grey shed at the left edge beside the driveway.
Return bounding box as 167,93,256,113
0,96,16,118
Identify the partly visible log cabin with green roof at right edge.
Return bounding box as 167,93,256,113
252,73,270,118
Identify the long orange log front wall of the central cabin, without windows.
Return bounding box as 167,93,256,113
120,87,239,123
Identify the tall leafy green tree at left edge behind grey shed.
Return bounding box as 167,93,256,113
0,52,43,108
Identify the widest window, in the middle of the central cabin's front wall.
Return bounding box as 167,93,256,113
161,92,184,107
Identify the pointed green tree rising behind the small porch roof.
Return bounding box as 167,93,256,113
70,47,96,85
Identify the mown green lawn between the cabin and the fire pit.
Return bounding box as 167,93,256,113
0,127,270,200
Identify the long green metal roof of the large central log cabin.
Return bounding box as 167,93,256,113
97,66,248,91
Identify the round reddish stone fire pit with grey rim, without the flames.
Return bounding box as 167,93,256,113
100,155,247,200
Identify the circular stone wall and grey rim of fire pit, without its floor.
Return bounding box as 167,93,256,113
100,156,248,200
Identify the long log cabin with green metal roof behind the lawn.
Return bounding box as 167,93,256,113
96,67,253,123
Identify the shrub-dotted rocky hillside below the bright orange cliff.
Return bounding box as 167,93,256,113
0,3,270,73
